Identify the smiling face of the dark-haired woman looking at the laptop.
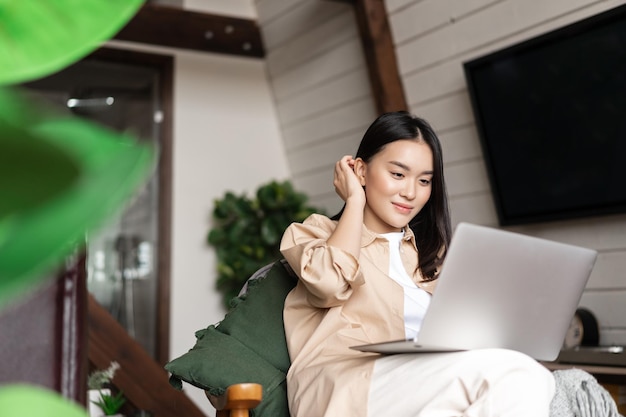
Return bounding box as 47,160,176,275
355,139,433,233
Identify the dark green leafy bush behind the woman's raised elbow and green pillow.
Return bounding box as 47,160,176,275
208,181,323,307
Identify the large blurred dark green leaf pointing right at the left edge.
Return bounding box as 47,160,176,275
0,88,156,308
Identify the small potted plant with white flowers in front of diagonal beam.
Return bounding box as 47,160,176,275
87,361,126,417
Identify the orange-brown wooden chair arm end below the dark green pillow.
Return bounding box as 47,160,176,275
205,383,263,417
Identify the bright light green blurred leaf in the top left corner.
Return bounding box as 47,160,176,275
0,0,144,85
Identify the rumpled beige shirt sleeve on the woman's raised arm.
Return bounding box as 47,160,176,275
280,214,364,308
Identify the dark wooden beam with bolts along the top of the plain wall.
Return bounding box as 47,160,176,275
114,4,265,58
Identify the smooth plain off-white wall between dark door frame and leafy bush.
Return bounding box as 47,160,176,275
108,21,289,415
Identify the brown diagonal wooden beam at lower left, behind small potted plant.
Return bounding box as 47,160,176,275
87,295,205,417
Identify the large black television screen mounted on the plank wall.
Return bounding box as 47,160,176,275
463,6,626,225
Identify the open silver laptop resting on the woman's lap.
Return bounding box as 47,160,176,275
352,223,597,361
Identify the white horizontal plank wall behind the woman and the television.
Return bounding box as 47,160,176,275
256,0,626,344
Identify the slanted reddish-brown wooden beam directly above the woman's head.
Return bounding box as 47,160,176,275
352,0,408,113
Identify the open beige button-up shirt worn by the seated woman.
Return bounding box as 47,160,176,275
281,214,436,417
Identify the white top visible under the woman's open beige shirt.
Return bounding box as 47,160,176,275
382,232,430,339
